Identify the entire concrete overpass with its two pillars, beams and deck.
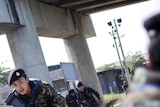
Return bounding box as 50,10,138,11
0,0,147,99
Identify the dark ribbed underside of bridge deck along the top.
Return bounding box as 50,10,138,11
39,0,148,14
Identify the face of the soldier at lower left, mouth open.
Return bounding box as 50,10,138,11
12,77,31,95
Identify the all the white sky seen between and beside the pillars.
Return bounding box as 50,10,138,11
0,0,160,68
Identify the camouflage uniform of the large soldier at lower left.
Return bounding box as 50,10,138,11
14,80,65,107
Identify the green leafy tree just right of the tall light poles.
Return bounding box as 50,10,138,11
126,52,145,72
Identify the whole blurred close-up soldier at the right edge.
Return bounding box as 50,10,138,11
121,13,160,107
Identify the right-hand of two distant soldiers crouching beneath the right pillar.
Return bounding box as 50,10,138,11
77,82,102,107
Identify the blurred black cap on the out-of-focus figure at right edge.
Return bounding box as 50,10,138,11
144,13,160,38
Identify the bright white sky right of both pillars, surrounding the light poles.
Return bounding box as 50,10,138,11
87,0,160,67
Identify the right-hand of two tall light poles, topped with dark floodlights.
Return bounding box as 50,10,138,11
108,18,131,84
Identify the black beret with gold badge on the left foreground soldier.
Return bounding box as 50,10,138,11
8,68,26,85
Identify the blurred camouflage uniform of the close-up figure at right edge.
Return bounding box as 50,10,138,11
120,68,160,107
